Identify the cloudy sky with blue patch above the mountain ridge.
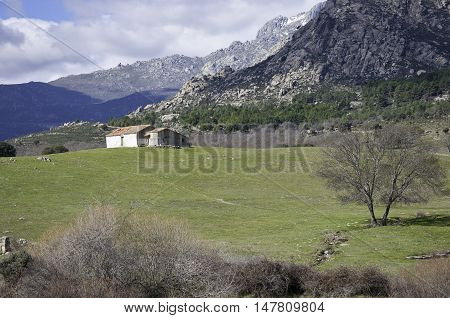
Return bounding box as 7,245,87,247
0,0,320,84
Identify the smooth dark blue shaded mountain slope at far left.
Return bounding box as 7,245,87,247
0,82,165,140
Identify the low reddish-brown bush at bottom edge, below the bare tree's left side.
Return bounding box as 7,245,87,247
307,267,389,297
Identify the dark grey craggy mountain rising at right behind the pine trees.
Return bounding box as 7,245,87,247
152,0,450,109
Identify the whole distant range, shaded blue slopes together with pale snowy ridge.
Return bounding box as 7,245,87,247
0,4,323,140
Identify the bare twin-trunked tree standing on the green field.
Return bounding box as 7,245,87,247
318,126,445,226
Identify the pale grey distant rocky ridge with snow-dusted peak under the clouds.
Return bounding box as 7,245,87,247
49,3,323,101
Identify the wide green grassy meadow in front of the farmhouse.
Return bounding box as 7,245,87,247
0,148,450,270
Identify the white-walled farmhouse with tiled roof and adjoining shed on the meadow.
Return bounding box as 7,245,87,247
106,125,189,148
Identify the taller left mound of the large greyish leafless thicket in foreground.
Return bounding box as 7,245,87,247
19,207,130,297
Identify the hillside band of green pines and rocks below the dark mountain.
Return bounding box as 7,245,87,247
110,68,450,133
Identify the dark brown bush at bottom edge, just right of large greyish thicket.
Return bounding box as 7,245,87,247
235,259,311,298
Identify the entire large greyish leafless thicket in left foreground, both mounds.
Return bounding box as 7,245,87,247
18,206,236,297
